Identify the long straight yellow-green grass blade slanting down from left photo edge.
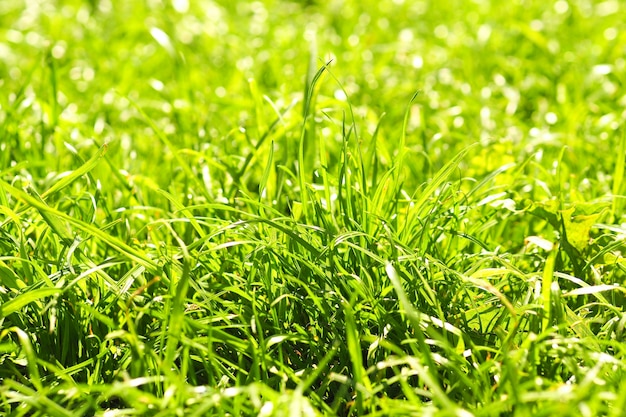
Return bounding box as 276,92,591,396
0,179,159,274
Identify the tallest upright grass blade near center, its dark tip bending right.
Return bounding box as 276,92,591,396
298,57,331,222
